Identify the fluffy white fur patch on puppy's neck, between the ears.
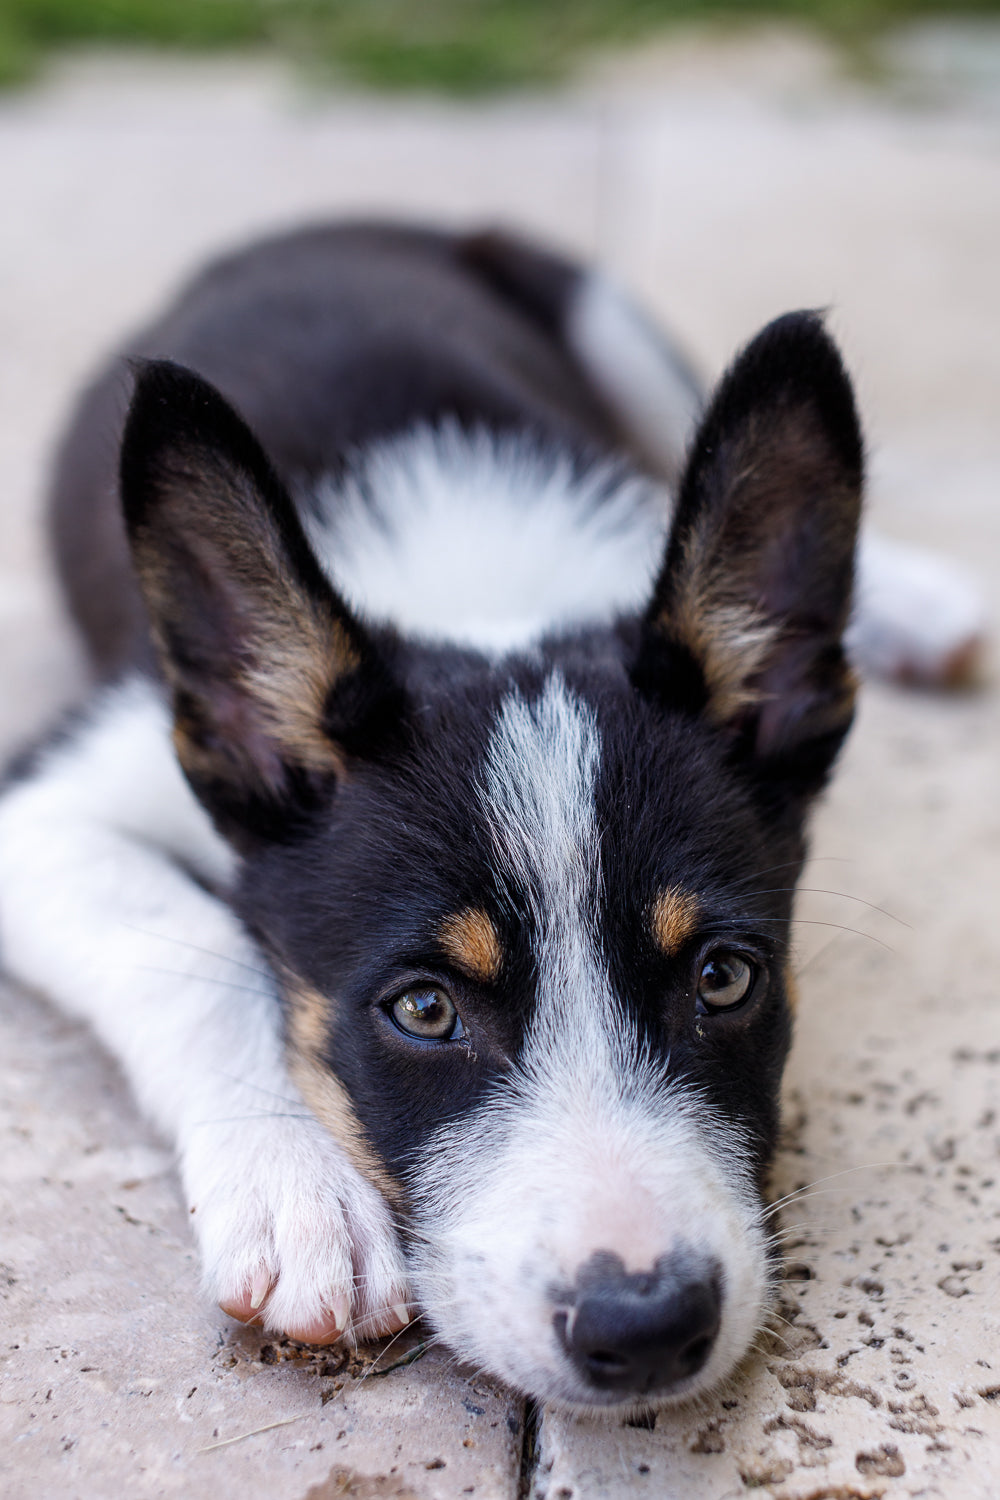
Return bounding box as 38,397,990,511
303,422,669,656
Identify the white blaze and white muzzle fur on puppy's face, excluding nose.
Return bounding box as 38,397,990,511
414,674,768,1406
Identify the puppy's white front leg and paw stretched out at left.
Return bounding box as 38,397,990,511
0,683,406,1343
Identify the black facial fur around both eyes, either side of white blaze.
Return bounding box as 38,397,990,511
238,647,802,1184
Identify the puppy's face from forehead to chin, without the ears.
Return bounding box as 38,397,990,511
243,651,799,1404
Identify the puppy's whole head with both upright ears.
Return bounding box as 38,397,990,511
123,315,861,1407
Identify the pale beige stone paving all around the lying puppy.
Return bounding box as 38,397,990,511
0,33,1000,1500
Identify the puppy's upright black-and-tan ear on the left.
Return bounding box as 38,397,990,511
121,362,400,843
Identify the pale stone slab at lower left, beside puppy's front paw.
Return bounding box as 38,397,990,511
0,990,522,1500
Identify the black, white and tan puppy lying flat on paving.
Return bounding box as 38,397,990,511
0,225,959,1407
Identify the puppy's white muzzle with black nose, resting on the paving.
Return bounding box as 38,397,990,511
401,1014,772,1418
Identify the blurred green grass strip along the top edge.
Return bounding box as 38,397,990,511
0,0,1000,95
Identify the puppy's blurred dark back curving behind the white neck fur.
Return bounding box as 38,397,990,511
52,224,700,677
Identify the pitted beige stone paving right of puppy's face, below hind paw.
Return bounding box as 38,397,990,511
535,692,1000,1500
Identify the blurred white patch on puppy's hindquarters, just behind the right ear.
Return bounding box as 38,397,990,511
567,272,702,485
